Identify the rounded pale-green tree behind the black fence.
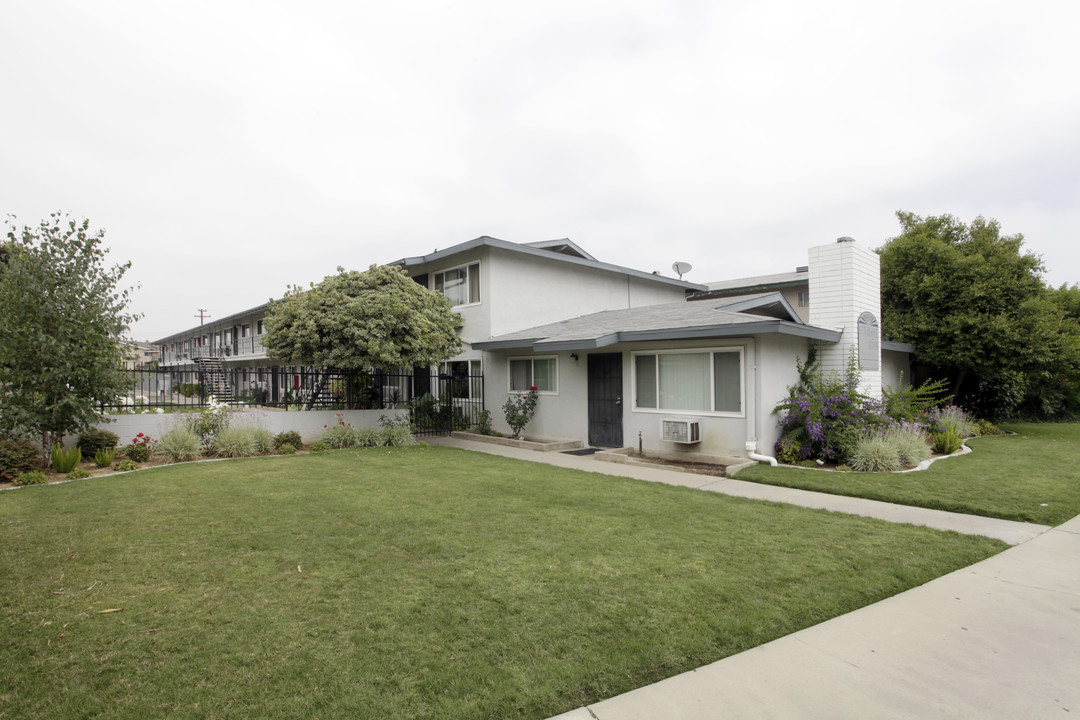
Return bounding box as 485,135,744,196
262,266,461,407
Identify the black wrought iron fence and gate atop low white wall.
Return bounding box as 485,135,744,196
102,367,484,435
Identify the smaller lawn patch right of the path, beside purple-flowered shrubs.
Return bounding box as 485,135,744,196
738,423,1080,525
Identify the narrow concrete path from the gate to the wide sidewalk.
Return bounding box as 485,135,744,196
427,437,1050,545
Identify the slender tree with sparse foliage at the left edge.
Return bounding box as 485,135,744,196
0,213,136,450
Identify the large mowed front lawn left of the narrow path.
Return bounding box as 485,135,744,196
0,446,1004,719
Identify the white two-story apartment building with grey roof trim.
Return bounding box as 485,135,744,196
158,236,914,464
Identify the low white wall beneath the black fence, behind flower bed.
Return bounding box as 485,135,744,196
81,410,407,447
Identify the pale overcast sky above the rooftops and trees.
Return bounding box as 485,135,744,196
0,0,1080,340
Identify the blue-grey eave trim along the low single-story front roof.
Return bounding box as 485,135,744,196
472,320,840,351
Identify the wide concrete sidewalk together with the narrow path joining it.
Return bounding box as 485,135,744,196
421,438,1080,720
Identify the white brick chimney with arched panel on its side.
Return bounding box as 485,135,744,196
810,237,881,397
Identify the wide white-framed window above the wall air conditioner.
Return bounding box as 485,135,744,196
634,348,743,415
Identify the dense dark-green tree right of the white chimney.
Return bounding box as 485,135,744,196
878,212,1080,417
